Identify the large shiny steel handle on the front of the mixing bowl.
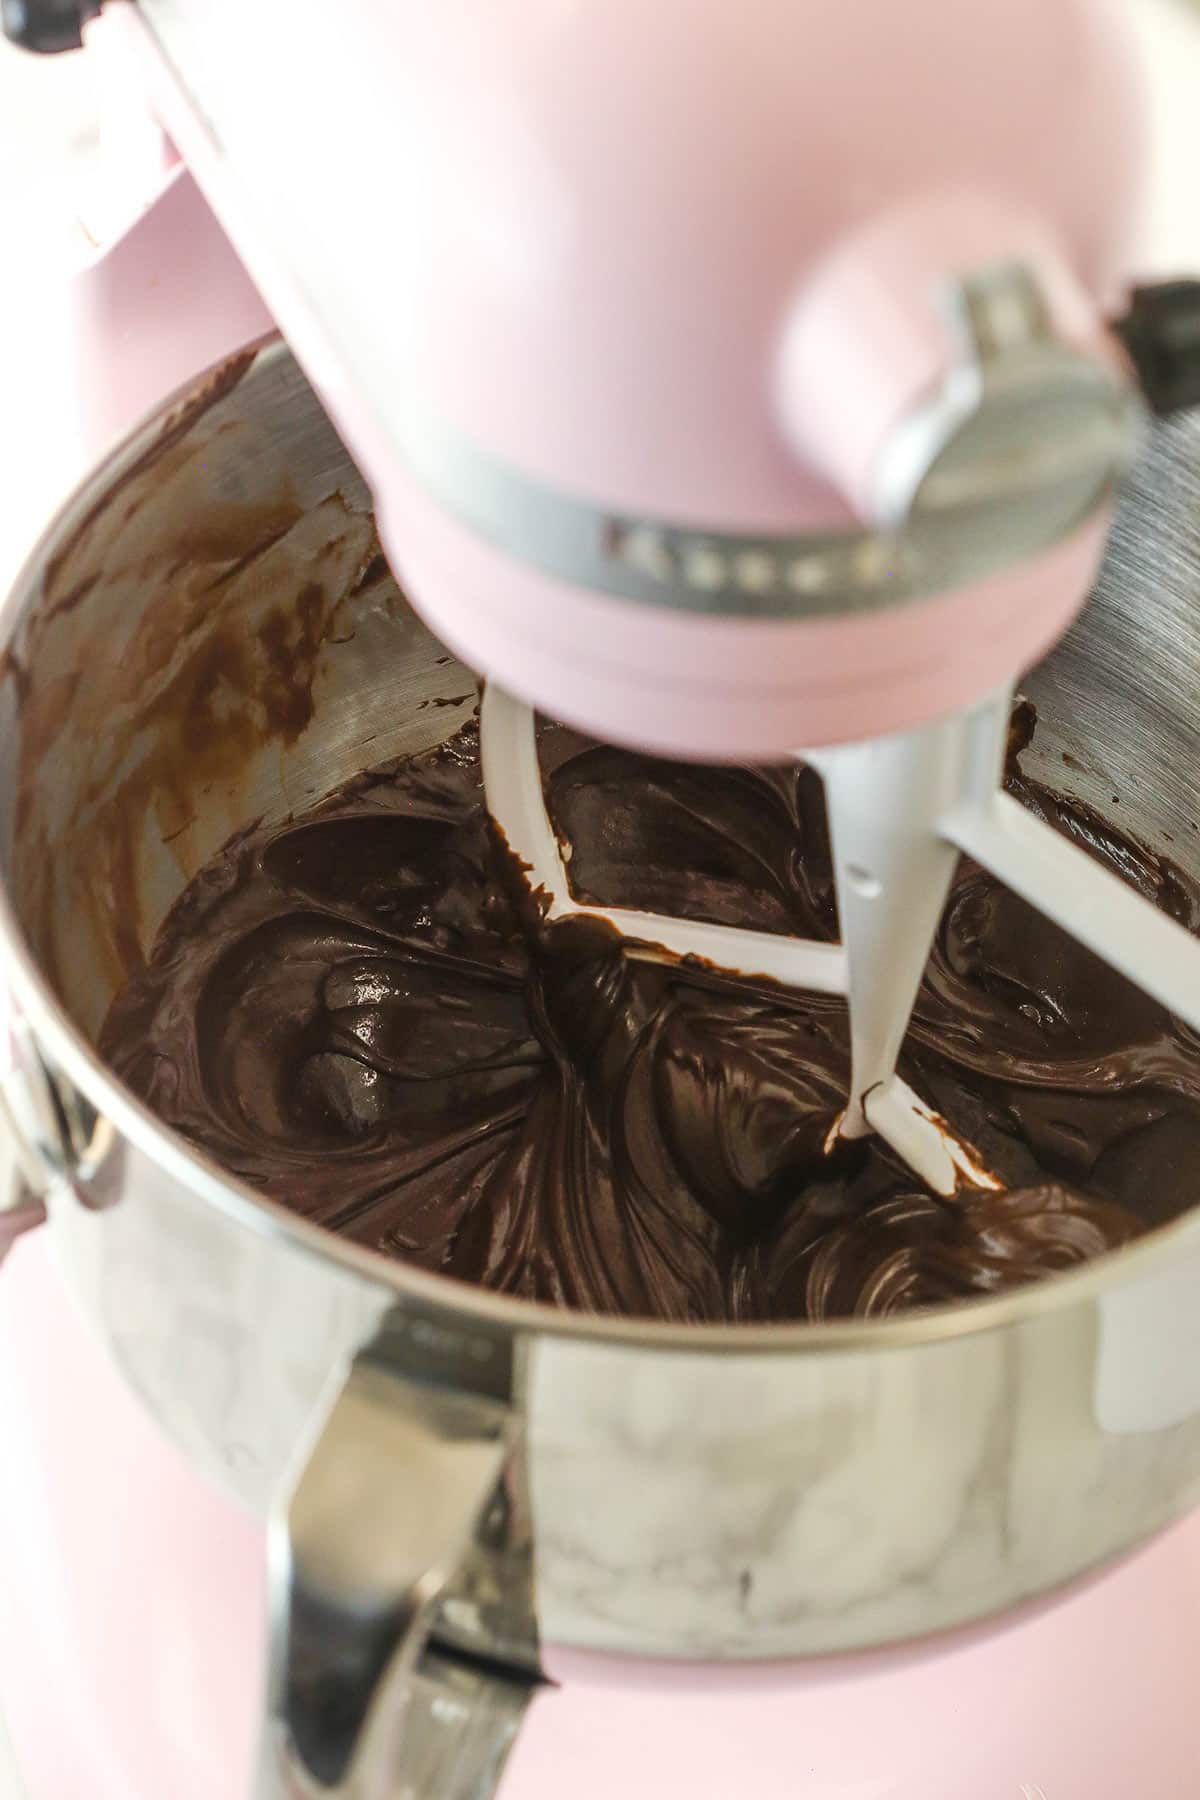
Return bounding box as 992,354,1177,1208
257,1307,536,1800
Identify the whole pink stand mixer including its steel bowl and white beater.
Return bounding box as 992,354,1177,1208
0,0,1200,1800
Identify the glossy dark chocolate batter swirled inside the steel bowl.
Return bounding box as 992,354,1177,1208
101,709,1200,1319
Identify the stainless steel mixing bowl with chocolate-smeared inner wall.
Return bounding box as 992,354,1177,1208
0,344,1200,1793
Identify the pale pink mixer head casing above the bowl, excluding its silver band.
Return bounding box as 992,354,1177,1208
113,0,1144,760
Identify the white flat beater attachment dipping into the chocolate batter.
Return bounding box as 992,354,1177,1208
480,684,1200,1195
